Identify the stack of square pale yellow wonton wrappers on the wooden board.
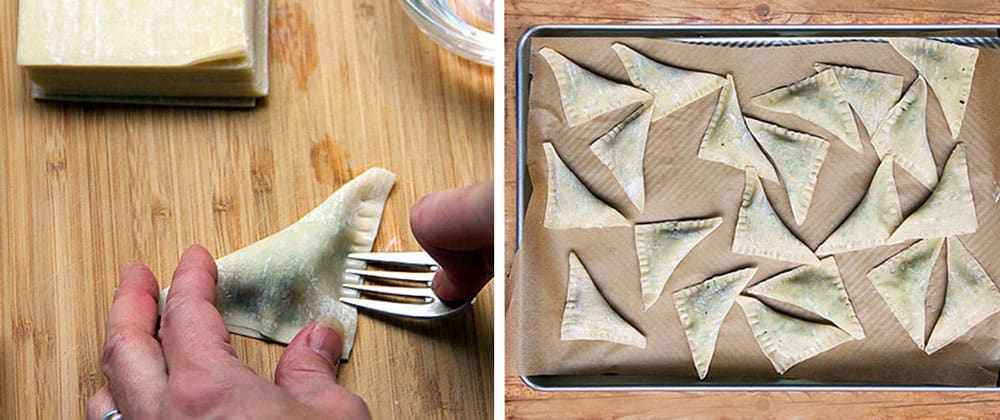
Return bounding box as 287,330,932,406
17,0,268,107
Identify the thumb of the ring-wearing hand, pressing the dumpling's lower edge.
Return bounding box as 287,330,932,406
274,321,368,418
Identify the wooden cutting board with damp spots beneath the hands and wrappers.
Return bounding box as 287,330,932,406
0,0,493,419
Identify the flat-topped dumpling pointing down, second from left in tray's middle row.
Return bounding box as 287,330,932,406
635,217,722,309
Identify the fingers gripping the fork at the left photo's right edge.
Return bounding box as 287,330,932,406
410,182,493,301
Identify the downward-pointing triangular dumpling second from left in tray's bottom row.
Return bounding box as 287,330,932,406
673,268,757,379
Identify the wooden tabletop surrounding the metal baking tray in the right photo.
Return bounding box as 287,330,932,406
503,0,1000,418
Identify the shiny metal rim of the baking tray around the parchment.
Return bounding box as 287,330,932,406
514,25,1000,392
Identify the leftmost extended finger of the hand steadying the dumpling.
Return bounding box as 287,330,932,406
101,264,167,416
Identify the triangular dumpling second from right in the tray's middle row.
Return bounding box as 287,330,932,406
816,157,903,255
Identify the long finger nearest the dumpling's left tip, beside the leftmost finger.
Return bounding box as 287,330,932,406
160,245,243,375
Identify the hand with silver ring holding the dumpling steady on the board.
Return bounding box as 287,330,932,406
87,246,370,420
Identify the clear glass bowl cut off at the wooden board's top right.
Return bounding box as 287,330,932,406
399,0,495,66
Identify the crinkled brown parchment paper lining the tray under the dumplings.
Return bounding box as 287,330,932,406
509,34,1000,386
